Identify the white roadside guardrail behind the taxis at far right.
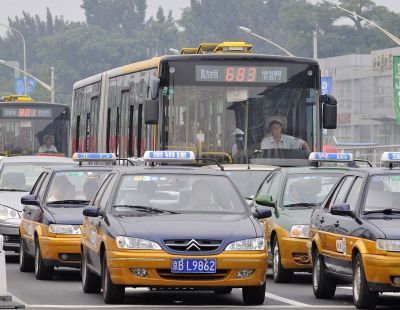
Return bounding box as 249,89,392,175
339,144,400,167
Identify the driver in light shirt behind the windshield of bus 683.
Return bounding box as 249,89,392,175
261,117,310,152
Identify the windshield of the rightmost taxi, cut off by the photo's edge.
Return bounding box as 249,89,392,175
364,175,400,213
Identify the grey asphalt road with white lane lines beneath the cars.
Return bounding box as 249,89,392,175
3,256,400,310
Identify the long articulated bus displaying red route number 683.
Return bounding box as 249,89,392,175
70,42,336,166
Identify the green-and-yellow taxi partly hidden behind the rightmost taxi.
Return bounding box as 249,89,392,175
251,153,353,283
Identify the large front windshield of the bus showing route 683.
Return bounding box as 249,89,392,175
161,60,318,166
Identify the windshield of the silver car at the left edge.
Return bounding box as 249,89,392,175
0,162,60,192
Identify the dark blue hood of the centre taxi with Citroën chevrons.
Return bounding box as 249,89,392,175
117,213,262,252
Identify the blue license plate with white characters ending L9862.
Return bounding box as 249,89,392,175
171,258,217,273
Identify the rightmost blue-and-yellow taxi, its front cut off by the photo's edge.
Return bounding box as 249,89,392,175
309,152,400,309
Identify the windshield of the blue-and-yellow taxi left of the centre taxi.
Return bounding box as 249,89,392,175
47,170,107,204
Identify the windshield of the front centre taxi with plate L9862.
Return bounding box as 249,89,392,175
114,174,246,213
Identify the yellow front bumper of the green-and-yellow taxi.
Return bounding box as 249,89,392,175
279,237,311,270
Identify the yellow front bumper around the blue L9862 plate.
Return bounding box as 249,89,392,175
107,251,268,288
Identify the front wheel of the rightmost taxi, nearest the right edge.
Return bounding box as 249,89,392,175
353,254,379,309
